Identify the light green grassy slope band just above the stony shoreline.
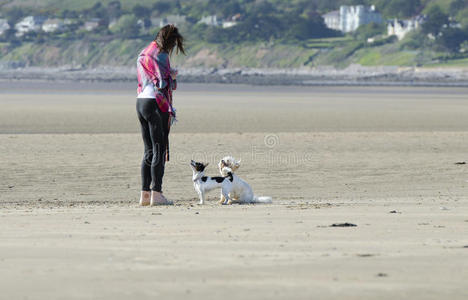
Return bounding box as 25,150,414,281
0,39,468,68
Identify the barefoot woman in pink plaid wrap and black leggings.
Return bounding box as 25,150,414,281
136,25,185,206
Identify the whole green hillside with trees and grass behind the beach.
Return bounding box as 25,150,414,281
0,0,468,68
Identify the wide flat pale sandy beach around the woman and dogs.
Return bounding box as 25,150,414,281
0,82,468,299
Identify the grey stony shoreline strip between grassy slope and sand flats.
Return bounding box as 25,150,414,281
0,65,468,87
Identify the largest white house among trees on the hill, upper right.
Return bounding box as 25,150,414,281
322,5,382,32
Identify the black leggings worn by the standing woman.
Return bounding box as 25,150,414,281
136,99,169,192
